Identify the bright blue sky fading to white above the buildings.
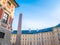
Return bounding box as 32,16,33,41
12,0,60,30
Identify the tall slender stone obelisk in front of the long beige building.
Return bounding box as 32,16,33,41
16,14,22,45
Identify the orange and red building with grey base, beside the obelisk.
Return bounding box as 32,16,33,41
0,0,18,45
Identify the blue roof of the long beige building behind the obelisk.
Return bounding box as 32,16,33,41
12,27,52,34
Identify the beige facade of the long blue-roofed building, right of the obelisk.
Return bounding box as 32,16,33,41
11,26,59,45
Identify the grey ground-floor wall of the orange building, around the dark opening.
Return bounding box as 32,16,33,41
0,28,11,45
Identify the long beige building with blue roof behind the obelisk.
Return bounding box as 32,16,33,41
11,24,60,45
